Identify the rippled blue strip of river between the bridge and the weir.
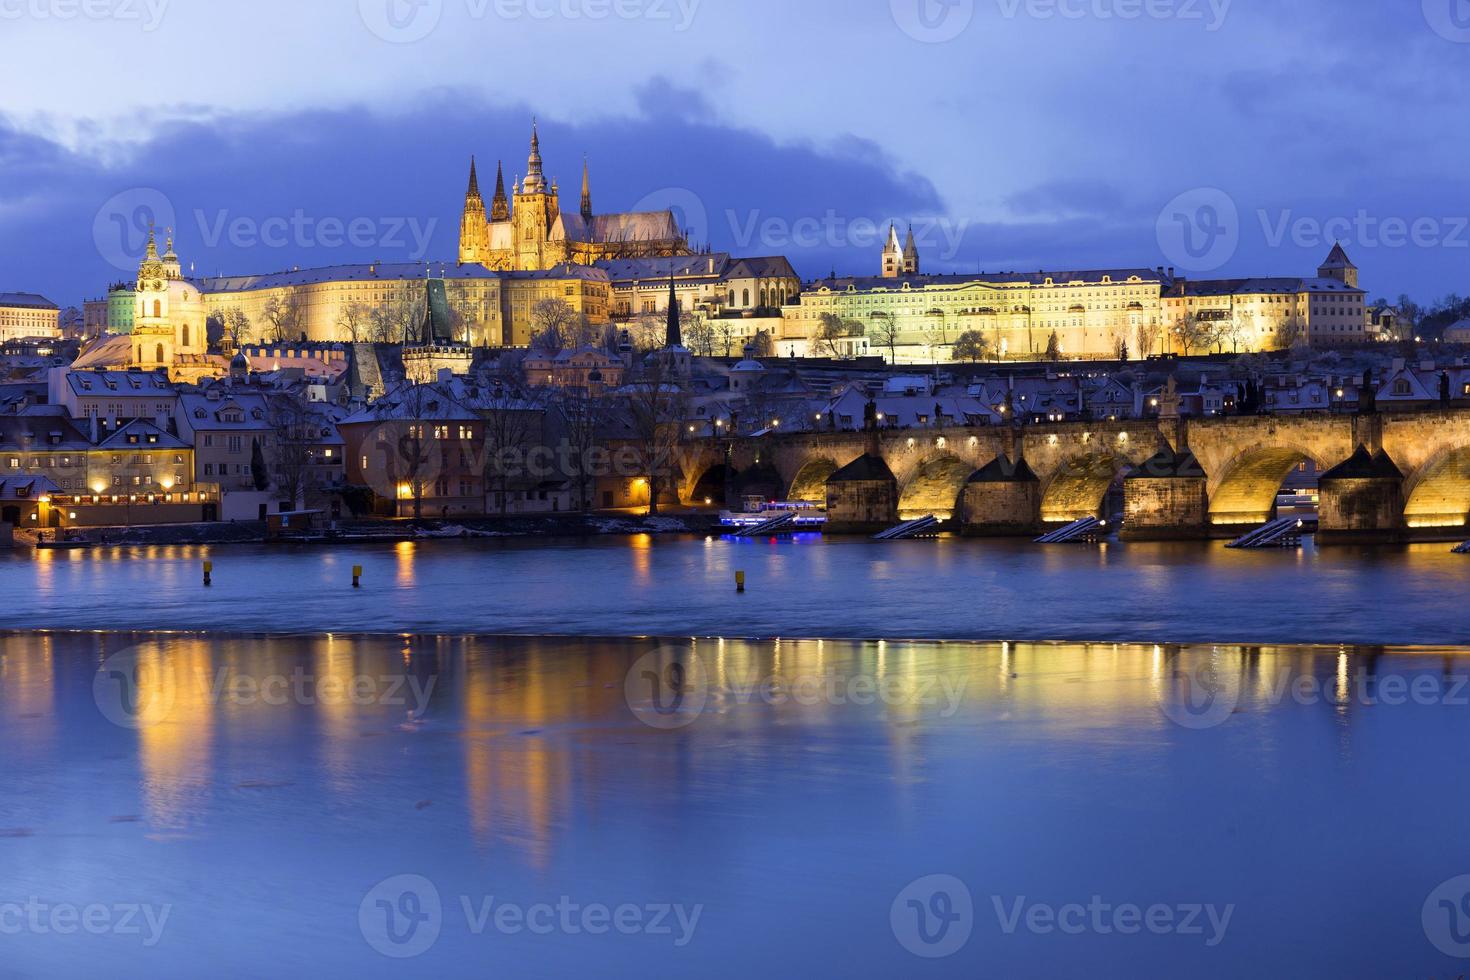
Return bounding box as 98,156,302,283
0,536,1470,645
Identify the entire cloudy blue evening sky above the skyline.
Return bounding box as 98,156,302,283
0,0,1470,304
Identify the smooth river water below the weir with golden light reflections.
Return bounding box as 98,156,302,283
0,635,1470,977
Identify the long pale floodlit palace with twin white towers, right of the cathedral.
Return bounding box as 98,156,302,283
782,238,1369,363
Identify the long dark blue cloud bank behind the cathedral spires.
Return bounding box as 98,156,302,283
0,93,942,303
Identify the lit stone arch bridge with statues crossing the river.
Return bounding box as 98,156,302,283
679,408,1470,539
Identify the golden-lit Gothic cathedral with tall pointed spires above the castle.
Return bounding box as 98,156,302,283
459,123,694,272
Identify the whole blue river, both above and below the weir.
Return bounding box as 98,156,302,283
0,539,1470,979
